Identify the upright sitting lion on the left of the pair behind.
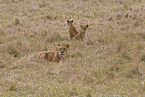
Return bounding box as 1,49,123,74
67,20,78,40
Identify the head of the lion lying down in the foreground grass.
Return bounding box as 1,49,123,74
58,44,69,57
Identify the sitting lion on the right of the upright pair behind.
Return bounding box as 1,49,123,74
72,25,89,41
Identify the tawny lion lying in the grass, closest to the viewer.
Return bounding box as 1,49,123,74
39,44,69,62
